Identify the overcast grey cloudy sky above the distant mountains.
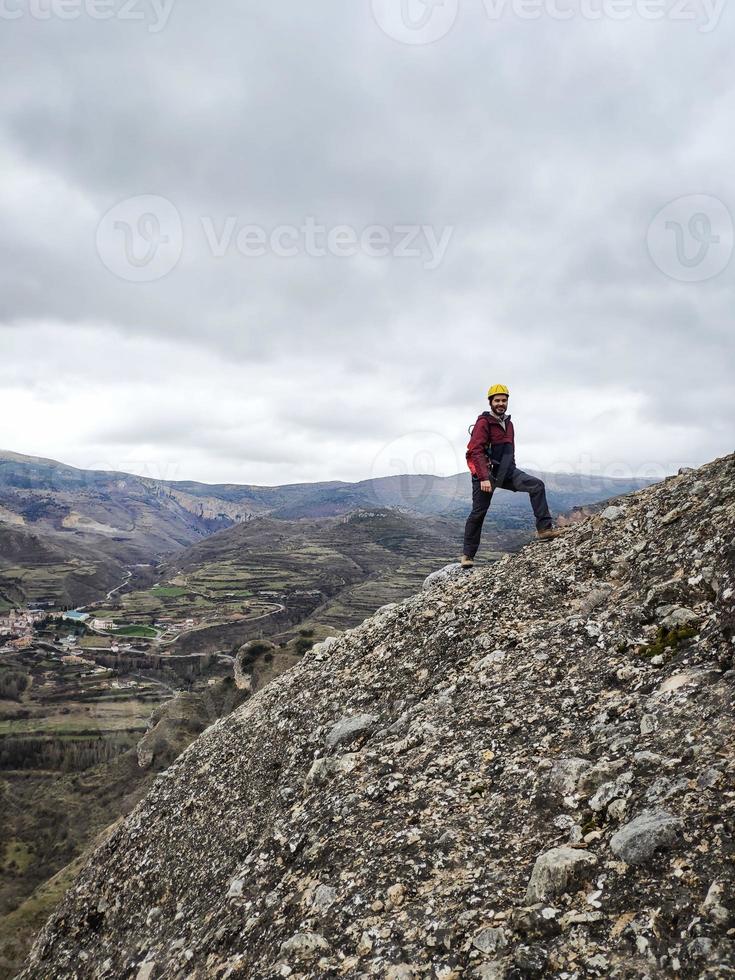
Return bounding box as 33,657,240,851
0,0,735,484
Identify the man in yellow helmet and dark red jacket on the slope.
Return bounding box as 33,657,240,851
460,385,562,568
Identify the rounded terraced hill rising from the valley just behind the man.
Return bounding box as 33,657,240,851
79,508,472,654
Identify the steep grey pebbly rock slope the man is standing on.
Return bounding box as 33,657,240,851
15,456,735,980
